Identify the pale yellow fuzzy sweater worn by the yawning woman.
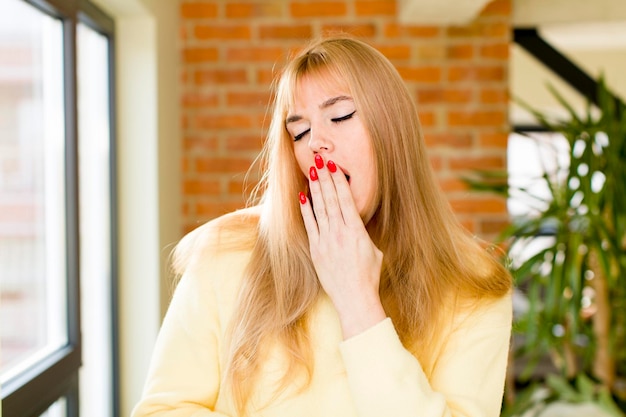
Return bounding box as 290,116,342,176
132,211,512,417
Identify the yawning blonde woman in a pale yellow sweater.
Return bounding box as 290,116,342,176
133,38,511,417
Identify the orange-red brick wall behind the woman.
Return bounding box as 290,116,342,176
180,0,511,237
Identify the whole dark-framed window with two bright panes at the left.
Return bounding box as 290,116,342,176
0,0,117,417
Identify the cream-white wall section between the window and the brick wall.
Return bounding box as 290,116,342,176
90,0,182,416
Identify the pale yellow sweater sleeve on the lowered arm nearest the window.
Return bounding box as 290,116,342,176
131,249,230,417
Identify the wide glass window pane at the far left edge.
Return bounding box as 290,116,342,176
0,0,67,382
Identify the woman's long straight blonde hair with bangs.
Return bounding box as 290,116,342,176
207,37,511,413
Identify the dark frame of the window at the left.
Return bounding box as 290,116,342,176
2,0,119,417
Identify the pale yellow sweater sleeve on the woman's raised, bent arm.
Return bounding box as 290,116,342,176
340,296,512,417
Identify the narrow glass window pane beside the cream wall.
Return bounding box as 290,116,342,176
77,24,112,417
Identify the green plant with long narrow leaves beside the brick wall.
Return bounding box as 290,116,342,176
468,83,626,412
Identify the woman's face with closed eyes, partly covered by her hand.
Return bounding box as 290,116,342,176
286,76,377,223
